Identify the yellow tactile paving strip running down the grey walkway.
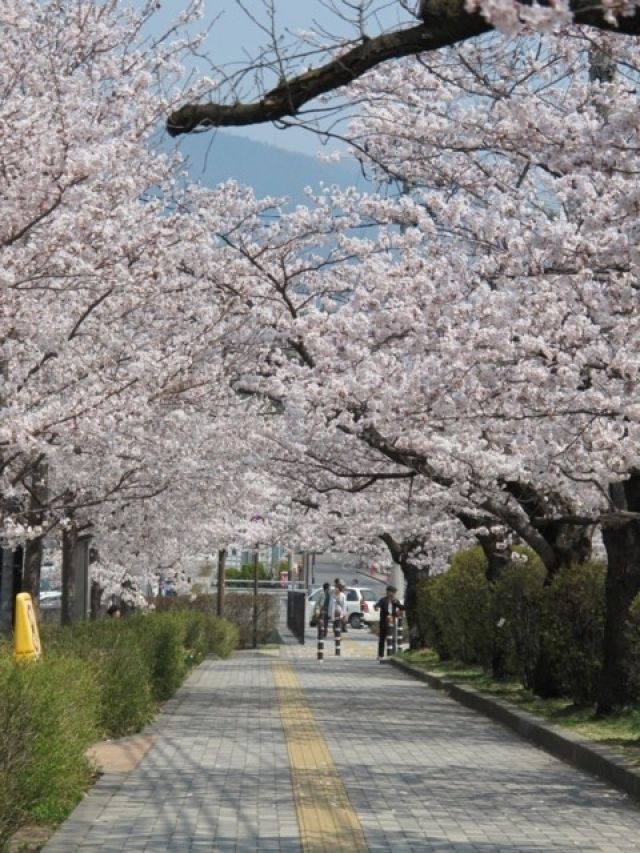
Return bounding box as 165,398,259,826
272,661,368,853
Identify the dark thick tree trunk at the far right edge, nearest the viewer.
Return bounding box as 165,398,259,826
598,472,640,714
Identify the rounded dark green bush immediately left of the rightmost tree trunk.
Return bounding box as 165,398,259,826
543,562,606,705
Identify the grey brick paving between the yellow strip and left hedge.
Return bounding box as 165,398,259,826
44,653,300,853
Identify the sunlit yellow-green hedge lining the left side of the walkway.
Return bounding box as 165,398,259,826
0,611,238,840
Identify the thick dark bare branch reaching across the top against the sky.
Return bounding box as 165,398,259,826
167,0,640,136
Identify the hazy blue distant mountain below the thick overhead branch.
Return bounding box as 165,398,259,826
170,131,371,205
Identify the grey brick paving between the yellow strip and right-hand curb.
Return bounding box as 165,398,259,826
295,660,640,853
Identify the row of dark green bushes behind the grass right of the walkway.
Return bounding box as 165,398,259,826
418,547,608,704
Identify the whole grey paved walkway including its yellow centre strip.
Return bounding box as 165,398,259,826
44,616,640,853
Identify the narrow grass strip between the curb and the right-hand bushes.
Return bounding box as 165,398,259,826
398,649,640,767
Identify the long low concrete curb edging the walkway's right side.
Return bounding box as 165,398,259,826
390,658,640,801
